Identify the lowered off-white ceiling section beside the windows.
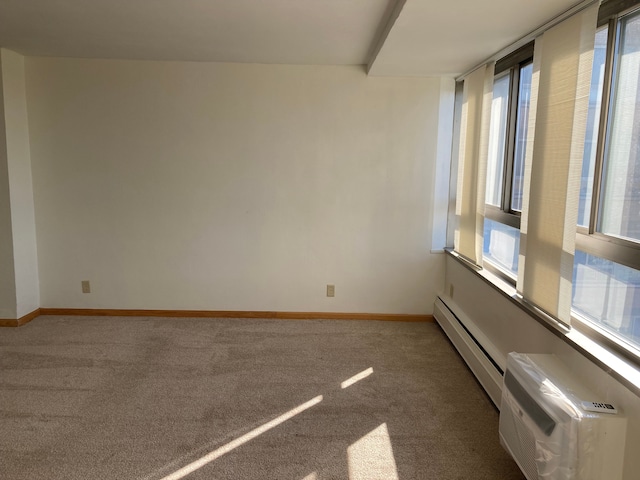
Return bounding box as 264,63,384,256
369,0,581,75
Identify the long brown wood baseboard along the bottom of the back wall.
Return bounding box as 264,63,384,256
39,308,434,322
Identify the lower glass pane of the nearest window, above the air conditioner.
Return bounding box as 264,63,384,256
572,250,640,347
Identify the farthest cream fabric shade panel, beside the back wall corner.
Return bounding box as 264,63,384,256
454,62,495,265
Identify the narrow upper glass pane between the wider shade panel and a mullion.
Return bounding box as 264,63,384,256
578,27,609,228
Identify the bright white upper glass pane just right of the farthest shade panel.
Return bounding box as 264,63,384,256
486,75,511,207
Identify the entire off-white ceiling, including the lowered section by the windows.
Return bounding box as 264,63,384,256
0,0,580,75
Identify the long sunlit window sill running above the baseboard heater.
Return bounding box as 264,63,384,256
446,249,640,396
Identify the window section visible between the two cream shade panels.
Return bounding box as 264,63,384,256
483,43,533,281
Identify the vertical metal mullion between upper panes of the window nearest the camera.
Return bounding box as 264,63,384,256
589,18,618,234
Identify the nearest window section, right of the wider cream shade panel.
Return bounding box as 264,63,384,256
572,0,640,349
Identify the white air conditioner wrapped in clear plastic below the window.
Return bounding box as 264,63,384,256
499,353,627,480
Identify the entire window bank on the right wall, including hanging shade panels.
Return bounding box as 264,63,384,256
454,0,640,365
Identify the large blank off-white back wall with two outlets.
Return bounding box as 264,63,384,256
26,58,444,313
